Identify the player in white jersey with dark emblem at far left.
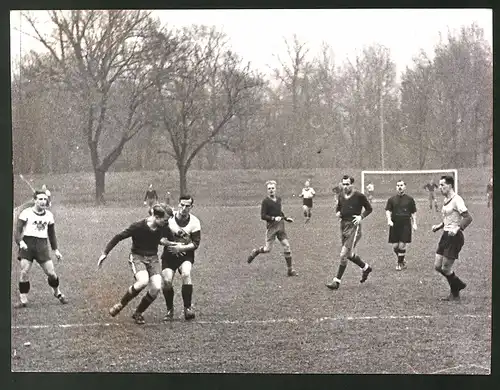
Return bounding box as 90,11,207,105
15,191,68,307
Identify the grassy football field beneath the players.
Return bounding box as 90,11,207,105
11,171,492,375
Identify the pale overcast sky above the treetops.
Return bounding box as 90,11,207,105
11,9,493,76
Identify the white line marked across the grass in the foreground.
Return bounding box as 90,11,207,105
11,314,491,329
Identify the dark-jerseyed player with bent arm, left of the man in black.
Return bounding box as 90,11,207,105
326,175,373,290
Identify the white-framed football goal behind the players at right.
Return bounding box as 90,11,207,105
360,169,459,201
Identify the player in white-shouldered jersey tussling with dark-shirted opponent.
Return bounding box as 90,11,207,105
161,195,201,321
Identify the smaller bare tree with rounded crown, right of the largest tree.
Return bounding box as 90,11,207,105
154,26,261,193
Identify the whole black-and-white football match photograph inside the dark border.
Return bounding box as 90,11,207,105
7,8,494,376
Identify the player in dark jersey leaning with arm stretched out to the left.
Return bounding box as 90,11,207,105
97,205,172,325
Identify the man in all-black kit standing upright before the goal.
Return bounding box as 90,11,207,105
385,180,417,271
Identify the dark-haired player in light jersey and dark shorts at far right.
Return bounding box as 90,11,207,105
432,176,472,301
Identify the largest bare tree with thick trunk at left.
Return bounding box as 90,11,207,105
23,10,170,203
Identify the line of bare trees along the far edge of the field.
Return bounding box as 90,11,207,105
12,10,493,203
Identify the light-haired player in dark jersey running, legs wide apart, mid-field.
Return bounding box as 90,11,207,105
247,180,298,276
